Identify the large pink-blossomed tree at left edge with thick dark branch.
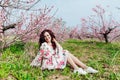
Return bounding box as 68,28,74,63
0,0,53,48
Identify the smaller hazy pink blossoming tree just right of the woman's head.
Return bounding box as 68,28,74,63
49,18,69,41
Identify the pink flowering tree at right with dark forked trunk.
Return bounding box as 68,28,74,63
82,5,120,43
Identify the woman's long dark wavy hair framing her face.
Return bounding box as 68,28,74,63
39,29,56,49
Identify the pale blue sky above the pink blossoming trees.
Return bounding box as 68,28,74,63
37,0,120,26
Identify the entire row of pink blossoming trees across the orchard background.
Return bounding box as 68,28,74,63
0,0,120,49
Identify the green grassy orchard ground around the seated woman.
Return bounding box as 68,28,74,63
0,39,120,80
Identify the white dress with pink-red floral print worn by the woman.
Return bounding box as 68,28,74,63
30,42,67,70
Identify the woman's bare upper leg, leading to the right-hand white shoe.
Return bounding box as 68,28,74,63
66,50,87,69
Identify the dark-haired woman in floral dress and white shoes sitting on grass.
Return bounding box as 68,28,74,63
30,29,98,75
